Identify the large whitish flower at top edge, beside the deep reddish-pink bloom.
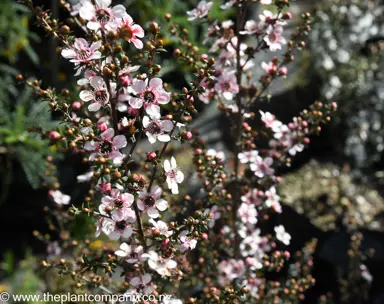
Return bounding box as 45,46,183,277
79,0,126,31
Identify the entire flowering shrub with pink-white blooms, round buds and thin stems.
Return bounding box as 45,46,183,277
18,0,336,303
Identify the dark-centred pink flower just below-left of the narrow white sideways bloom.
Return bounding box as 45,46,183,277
137,186,168,218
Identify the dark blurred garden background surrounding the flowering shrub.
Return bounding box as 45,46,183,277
0,0,384,303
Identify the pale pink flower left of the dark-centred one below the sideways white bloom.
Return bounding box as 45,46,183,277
99,189,135,221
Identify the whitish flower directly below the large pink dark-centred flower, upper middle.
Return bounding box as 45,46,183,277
143,116,173,144
